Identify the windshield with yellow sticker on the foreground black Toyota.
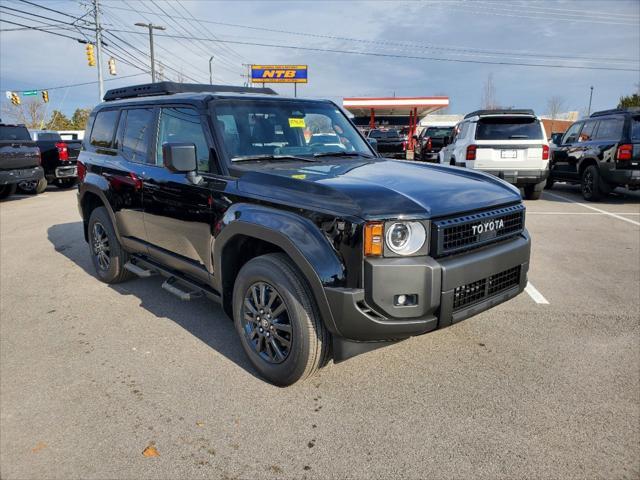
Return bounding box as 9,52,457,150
214,100,373,161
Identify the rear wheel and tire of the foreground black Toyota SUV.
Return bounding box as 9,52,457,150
87,207,133,284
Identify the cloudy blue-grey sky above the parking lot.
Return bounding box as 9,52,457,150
0,0,640,121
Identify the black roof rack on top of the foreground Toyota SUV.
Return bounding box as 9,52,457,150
103,82,277,102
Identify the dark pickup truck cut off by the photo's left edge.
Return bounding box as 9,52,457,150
0,123,44,198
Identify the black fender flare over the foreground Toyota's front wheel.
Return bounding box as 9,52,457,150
213,204,345,335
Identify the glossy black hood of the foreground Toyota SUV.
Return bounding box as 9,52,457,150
237,157,521,220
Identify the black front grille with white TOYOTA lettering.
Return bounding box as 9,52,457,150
432,204,525,257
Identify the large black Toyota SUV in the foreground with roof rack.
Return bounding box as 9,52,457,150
78,82,530,385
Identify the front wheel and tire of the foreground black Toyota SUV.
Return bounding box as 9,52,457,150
233,253,330,386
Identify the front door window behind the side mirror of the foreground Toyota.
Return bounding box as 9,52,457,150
156,107,211,172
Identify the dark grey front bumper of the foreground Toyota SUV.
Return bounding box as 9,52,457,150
325,230,531,342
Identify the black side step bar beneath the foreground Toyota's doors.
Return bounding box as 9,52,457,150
124,254,222,302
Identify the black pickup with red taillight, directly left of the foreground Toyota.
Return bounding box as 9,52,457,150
29,130,82,190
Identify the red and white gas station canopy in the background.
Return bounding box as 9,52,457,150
342,97,449,118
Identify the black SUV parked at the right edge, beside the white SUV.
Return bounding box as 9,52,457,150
547,109,640,201
